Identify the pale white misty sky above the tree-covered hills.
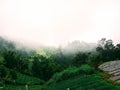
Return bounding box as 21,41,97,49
0,0,120,46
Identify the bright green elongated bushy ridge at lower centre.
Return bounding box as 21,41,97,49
47,65,95,84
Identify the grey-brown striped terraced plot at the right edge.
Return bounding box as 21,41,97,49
99,60,120,83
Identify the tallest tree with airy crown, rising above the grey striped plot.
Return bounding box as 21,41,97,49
96,38,115,61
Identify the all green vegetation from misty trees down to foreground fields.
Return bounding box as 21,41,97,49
0,38,120,90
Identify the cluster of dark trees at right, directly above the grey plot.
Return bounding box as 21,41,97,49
87,38,120,67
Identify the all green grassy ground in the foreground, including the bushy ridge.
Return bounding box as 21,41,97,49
0,65,120,90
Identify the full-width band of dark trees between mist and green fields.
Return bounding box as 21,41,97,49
0,38,120,83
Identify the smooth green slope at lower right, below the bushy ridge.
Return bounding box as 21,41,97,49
45,74,120,90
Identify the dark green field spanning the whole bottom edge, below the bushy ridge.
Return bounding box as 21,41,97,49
0,74,120,90
